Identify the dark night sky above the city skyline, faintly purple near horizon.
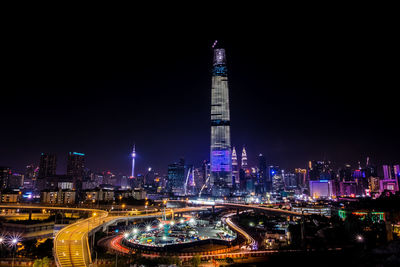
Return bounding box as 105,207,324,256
0,6,400,176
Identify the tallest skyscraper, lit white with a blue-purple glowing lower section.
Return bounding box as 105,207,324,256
210,42,232,196
